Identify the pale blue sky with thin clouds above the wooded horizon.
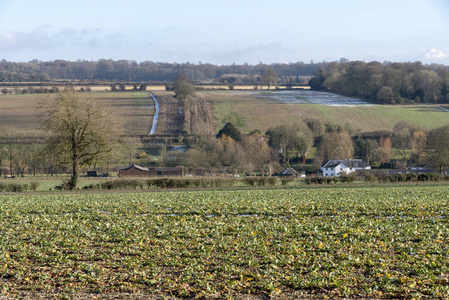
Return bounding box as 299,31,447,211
0,0,449,65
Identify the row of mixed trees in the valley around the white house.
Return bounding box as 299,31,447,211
173,119,449,174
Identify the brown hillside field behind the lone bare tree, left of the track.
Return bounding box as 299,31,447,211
0,92,155,137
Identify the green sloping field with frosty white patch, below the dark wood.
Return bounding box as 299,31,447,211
203,91,449,132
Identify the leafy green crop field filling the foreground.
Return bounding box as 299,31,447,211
0,185,449,299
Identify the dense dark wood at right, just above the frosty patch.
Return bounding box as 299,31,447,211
309,60,449,104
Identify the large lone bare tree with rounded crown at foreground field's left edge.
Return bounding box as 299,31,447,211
39,90,120,190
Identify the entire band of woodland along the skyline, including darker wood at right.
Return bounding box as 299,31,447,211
0,59,449,104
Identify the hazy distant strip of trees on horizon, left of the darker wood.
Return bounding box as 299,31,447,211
0,59,327,84
